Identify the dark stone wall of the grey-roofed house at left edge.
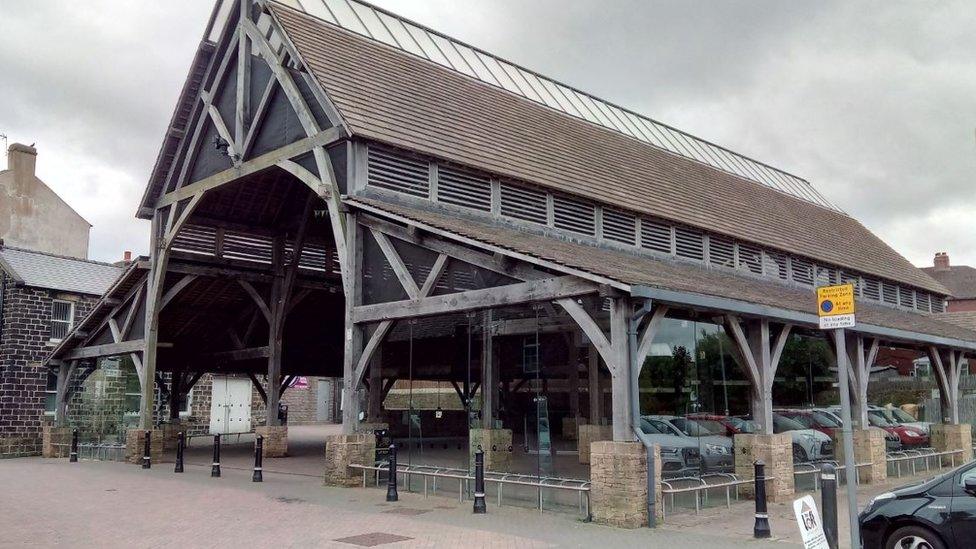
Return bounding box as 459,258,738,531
0,280,97,458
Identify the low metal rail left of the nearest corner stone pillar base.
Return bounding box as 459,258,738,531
349,464,590,520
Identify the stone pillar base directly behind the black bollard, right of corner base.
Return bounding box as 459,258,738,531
733,433,794,502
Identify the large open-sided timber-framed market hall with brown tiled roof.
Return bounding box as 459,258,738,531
49,0,976,526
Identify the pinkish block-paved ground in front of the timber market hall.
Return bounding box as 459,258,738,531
0,458,796,549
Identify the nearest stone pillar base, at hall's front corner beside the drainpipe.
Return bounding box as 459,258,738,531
589,441,662,528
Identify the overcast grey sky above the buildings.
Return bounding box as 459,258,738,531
0,0,976,266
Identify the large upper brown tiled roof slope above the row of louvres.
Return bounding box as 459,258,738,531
268,2,946,294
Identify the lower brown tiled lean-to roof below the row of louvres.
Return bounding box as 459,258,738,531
347,198,976,342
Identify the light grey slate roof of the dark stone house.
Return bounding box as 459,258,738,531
0,247,122,295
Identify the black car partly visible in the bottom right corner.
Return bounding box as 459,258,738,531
860,462,976,549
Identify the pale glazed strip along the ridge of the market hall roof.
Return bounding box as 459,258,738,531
269,0,848,215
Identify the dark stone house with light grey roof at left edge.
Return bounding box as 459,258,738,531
0,245,121,457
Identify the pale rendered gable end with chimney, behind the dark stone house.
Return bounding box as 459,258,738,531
0,143,91,259
